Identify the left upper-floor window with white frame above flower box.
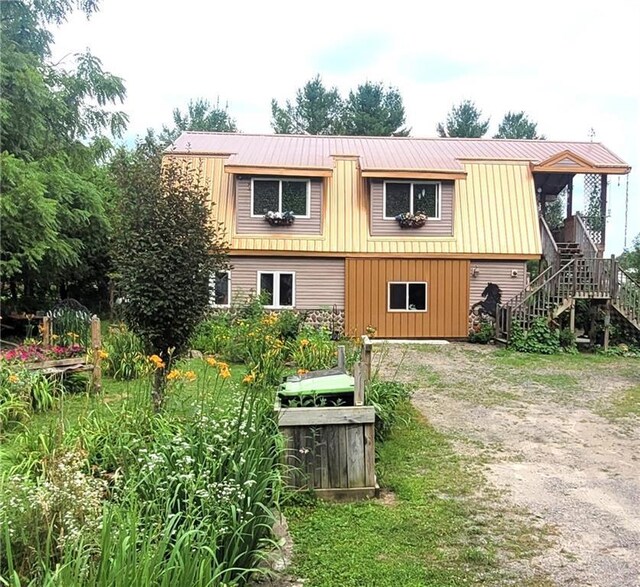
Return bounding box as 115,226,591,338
251,178,311,218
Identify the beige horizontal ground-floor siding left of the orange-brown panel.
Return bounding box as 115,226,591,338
230,257,344,310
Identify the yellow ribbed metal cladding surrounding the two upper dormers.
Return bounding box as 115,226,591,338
170,156,541,259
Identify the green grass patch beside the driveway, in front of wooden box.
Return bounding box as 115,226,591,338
285,406,542,587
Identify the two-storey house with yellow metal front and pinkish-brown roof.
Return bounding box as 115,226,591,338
169,132,629,338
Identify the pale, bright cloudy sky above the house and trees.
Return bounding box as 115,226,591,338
53,0,640,253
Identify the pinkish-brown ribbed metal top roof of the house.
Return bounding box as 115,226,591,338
168,132,629,173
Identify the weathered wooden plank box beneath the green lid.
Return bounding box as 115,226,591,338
274,399,378,500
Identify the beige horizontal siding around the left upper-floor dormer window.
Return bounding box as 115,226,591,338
236,176,323,234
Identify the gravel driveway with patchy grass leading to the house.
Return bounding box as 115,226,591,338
381,344,640,587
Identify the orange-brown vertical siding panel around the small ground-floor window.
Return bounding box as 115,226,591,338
345,258,469,338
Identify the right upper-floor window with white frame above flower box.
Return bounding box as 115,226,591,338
383,181,440,220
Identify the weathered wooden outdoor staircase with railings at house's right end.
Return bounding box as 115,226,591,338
496,258,640,343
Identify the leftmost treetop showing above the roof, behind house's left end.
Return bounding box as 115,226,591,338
159,98,238,144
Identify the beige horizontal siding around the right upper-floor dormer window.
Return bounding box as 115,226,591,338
369,180,454,237
